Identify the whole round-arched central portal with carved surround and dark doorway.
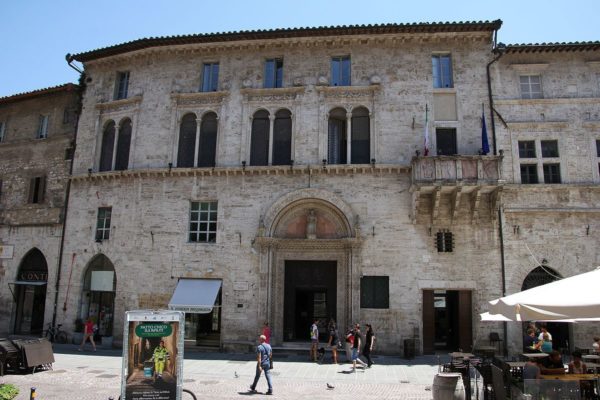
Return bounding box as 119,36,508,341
255,189,361,344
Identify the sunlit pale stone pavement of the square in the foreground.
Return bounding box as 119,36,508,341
0,345,437,400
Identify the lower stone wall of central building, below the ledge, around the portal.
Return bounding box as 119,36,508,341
59,169,500,352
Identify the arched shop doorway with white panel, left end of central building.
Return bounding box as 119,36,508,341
79,254,117,336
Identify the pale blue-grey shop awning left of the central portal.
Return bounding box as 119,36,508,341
169,279,222,314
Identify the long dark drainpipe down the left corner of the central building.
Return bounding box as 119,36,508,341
52,54,85,332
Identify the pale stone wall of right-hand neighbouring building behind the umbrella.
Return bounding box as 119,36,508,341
492,52,600,349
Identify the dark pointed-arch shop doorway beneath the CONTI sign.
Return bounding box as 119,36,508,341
14,249,48,334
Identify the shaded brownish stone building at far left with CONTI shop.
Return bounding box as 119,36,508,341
0,84,79,336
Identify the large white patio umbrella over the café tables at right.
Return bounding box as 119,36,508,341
481,268,600,322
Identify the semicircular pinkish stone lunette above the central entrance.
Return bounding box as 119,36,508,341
264,189,355,239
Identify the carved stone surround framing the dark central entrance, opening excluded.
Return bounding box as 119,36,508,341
254,189,361,344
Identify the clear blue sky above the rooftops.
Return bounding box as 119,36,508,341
0,0,600,97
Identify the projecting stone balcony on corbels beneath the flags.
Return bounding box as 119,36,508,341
411,155,504,224
